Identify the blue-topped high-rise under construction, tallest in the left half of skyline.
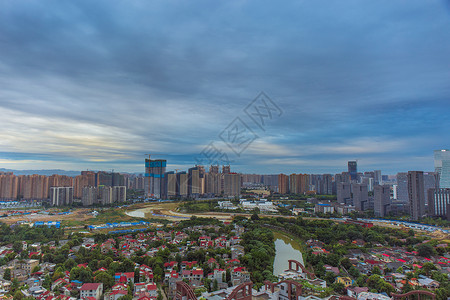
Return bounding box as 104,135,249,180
145,159,167,199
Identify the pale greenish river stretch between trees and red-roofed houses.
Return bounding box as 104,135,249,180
273,232,304,275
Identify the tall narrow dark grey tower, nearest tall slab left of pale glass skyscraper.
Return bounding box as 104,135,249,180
408,171,425,220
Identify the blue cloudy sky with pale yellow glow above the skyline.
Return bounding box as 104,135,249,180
0,0,450,174
